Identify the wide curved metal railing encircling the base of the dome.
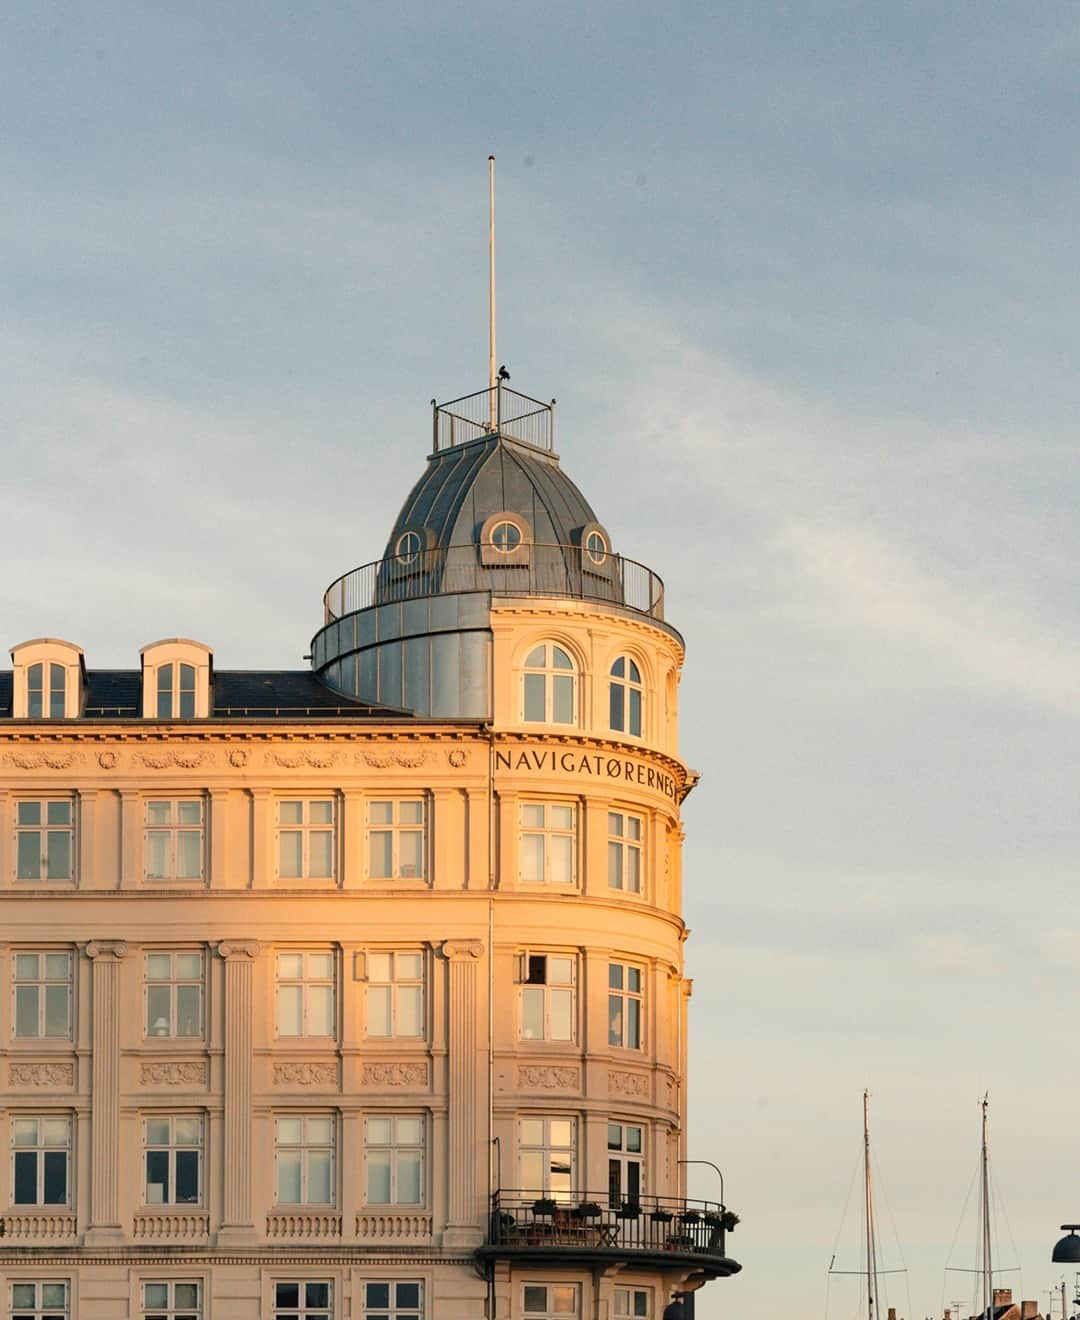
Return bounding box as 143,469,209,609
322,544,664,623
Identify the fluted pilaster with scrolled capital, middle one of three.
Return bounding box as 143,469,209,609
218,940,259,1245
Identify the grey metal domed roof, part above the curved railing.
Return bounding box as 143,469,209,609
386,434,597,558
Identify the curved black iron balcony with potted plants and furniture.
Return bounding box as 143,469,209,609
478,1188,742,1278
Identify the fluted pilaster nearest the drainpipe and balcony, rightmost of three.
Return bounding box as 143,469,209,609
442,940,487,1247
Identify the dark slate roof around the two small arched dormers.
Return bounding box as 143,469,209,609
0,669,412,719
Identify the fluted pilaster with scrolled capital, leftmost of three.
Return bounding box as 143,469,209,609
84,940,128,1246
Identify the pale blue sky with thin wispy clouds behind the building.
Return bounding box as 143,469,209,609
0,0,1080,1320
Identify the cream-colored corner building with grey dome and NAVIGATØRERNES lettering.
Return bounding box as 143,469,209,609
0,388,738,1320
